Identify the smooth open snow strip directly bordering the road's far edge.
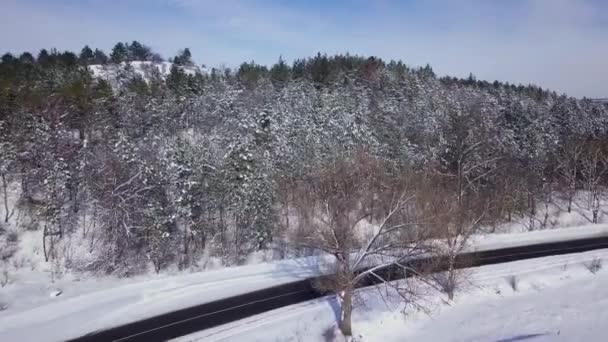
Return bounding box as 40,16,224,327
0,225,608,341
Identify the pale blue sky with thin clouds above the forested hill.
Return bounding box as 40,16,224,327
0,0,608,97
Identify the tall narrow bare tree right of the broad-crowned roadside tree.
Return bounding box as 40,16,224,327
434,101,502,300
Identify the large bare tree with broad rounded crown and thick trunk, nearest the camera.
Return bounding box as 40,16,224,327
295,153,426,336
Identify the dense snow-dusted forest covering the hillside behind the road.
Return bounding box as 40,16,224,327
0,41,608,276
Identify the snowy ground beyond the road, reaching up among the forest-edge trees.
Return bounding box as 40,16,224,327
0,183,608,341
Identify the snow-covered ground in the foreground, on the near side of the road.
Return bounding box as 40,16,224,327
176,250,608,342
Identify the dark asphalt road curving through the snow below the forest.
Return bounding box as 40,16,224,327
73,237,608,342
